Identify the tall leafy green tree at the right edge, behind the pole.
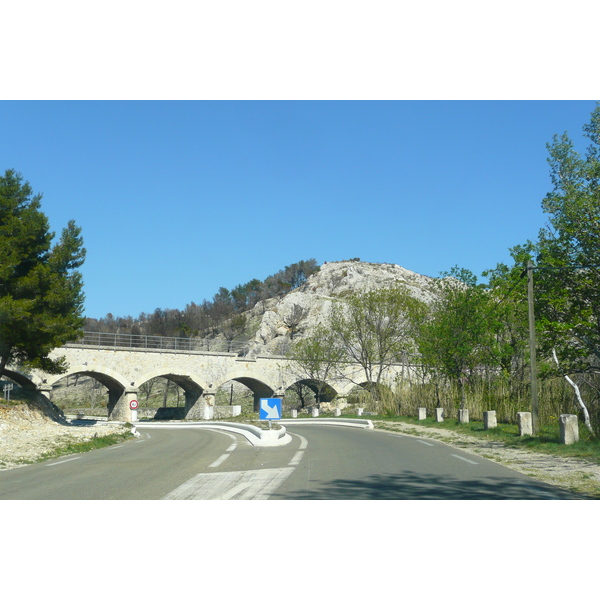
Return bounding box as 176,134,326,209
535,104,600,372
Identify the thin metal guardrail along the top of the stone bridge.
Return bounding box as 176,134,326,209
66,331,289,356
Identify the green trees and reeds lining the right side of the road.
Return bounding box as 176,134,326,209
292,103,600,439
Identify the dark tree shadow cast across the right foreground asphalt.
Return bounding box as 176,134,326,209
271,471,582,500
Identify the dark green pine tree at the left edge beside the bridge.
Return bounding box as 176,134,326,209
0,169,85,376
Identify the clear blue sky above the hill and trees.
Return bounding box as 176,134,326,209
0,101,595,318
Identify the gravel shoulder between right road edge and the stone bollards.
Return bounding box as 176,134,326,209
373,420,600,499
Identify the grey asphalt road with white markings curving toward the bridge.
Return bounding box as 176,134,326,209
0,424,574,500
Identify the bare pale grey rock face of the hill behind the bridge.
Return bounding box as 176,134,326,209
250,261,436,354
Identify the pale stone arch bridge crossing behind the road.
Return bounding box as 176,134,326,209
5,334,418,421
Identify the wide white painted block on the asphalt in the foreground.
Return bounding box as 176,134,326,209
163,467,294,500
